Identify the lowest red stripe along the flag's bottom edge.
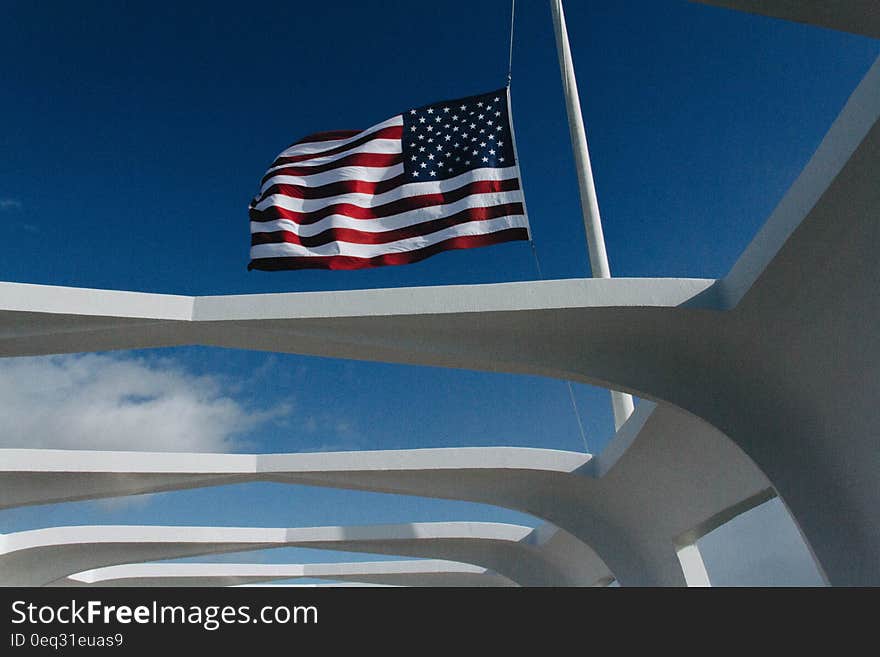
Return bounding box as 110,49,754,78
248,228,529,271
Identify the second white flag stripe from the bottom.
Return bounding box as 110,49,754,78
251,190,522,237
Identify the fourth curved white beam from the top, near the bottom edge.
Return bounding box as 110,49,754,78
58,559,516,586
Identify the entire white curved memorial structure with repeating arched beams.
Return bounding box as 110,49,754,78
0,0,880,586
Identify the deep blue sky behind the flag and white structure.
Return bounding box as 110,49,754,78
0,0,880,583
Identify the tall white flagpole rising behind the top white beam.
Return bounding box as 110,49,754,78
550,0,634,429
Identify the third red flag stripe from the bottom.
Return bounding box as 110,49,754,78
249,178,519,225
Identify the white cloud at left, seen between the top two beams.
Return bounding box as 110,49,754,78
0,354,289,452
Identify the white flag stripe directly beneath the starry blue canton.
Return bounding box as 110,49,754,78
256,166,519,212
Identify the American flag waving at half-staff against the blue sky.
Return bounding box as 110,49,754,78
248,89,529,270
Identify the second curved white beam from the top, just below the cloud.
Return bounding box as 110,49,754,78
0,402,773,585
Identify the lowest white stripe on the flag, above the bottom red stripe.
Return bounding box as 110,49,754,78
251,215,528,259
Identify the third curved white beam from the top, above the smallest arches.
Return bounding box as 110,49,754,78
0,522,607,586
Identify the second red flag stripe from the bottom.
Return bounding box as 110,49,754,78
251,203,525,248
